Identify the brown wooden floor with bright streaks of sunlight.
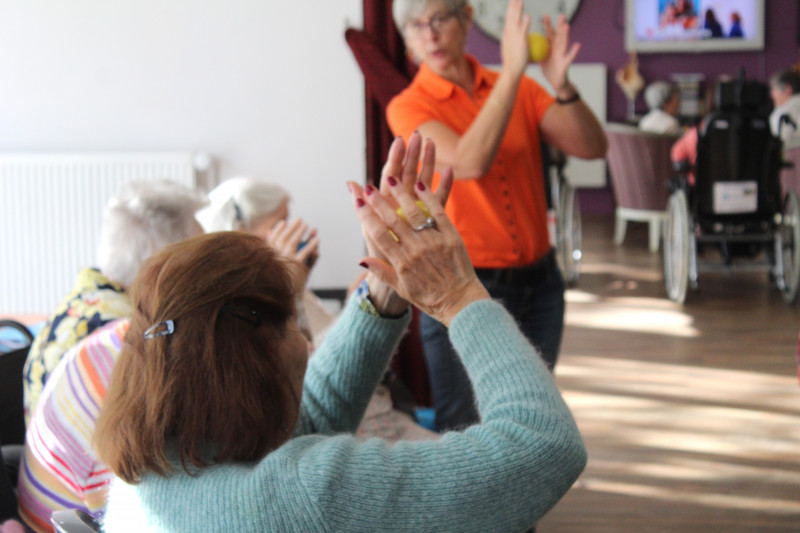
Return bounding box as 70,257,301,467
537,217,800,533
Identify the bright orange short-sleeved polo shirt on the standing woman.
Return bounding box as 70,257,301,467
386,56,554,268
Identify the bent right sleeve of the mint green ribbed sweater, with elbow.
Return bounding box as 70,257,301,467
298,300,586,532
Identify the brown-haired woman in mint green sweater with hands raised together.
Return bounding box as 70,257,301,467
96,138,586,533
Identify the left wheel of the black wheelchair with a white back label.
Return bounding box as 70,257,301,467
664,190,694,304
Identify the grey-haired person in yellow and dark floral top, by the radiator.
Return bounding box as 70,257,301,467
23,180,206,423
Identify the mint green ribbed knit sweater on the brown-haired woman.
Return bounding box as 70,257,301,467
105,300,586,533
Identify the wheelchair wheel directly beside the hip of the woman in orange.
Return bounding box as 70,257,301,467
541,143,583,285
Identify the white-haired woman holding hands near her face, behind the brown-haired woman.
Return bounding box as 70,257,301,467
196,177,324,344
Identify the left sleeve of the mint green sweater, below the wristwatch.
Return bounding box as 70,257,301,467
294,298,410,436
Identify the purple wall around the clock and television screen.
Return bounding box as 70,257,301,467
467,0,800,121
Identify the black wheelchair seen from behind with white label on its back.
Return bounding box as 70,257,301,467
664,75,800,303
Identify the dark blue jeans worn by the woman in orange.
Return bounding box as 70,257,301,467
420,258,565,431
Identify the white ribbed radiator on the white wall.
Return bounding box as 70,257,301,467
0,152,208,317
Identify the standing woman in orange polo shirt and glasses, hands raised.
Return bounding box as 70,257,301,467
382,0,607,430
